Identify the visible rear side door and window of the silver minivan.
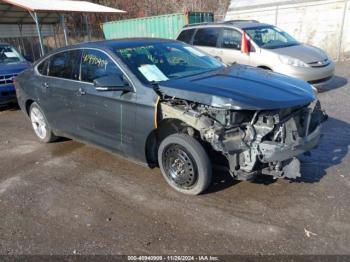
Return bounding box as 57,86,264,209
193,27,220,58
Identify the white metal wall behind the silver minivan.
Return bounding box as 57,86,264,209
225,0,350,60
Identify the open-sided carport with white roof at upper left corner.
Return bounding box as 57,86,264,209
0,0,125,59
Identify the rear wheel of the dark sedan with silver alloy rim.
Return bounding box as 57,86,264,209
29,102,57,143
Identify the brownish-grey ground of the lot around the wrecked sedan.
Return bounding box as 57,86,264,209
0,64,350,255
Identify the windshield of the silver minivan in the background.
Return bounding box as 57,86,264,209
244,26,299,49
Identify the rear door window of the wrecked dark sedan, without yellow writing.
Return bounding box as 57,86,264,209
49,50,81,80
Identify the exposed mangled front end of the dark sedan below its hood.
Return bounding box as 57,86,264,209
159,98,327,180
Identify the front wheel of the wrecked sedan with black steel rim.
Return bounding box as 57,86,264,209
158,134,212,195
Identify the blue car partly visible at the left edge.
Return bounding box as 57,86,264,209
0,43,30,105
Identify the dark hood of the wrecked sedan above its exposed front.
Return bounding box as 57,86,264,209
159,65,316,110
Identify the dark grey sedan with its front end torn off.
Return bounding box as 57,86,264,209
16,39,324,194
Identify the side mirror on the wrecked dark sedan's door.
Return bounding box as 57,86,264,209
94,75,134,92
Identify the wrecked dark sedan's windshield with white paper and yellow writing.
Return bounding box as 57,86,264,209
113,42,224,83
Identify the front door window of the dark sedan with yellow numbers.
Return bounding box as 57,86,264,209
81,50,122,83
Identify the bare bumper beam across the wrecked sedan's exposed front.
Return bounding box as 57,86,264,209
259,125,321,163
